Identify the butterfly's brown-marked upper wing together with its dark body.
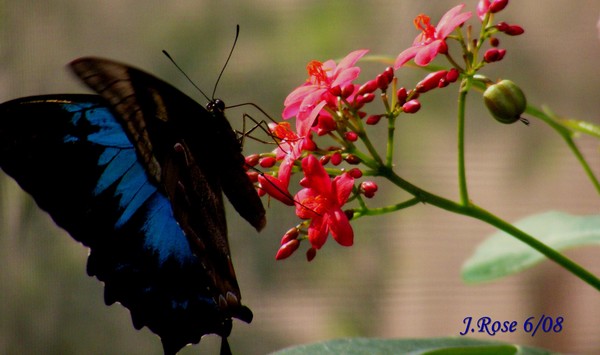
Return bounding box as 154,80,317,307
71,57,266,230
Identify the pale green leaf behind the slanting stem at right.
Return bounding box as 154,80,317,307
462,211,600,283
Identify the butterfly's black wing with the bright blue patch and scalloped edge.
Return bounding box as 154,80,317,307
0,95,252,353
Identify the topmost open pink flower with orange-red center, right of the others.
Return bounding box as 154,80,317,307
394,4,471,69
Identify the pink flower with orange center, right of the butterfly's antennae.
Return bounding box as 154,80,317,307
282,49,368,135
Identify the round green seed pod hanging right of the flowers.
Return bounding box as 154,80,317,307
483,80,527,123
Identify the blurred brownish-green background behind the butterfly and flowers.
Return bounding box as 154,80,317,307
0,0,600,354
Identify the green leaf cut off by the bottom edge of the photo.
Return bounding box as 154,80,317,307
272,337,558,355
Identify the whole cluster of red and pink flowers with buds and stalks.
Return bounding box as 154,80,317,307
246,0,523,261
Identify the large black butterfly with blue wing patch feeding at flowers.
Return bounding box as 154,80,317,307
0,57,266,354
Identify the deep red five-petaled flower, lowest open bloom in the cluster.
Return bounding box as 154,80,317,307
295,155,354,249
